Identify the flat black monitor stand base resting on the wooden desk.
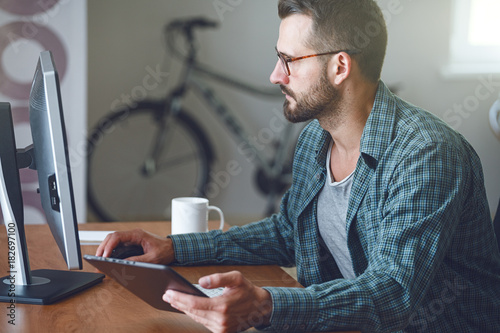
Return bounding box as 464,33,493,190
0,269,104,305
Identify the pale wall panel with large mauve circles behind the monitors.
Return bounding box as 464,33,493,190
0,0,87,224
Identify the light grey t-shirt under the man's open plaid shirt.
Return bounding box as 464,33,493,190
317,142,356,279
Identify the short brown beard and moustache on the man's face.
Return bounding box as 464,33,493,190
281,68,340,123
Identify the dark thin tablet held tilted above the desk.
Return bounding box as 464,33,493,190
83,254,223,312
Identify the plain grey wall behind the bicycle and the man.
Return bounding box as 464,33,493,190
88,0,500,224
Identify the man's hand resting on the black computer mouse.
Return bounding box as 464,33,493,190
96,229,175,265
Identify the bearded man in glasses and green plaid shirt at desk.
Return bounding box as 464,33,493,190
97,0,500,332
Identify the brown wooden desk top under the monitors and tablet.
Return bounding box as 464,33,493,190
0,222,360,333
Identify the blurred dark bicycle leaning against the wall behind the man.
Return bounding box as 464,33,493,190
87,18,296,221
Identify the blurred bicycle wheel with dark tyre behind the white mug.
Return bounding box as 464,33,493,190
87,102,213,221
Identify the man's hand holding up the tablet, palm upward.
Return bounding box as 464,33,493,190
163,271,272,333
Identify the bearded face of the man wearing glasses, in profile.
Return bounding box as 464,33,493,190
270,14,340,123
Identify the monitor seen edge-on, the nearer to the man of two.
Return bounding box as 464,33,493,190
29,51,82,269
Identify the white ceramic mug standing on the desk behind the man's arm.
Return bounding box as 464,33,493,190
172,197,224,235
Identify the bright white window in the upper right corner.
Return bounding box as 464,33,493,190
445,0,500,75
